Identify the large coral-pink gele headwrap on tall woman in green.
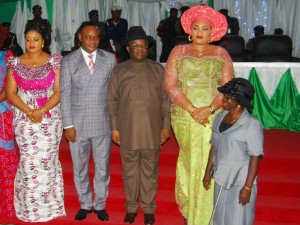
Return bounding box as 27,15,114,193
181,5,228,41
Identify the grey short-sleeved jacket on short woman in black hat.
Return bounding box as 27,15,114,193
211,109,264,189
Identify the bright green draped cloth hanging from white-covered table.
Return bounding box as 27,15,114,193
248,68,300,132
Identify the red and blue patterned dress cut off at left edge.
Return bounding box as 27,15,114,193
0,47,19,218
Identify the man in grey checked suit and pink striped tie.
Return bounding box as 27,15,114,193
60,21,116,221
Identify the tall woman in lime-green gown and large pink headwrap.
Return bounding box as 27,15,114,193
164,5,234,225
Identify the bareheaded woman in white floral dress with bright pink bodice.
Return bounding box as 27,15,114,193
6,25,65,222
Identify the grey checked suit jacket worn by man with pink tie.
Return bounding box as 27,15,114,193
60,49,116,138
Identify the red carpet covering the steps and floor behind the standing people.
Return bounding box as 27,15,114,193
0,130,300,225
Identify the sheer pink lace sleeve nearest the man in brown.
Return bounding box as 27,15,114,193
164,45,192,108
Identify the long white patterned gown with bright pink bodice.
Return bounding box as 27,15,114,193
8,54,65,222
